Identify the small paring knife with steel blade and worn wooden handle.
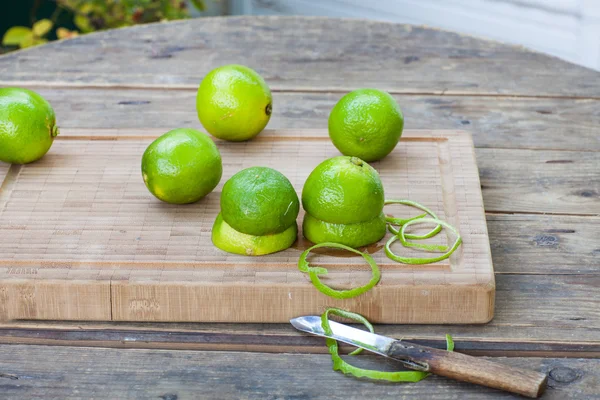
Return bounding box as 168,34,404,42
290,316,548,398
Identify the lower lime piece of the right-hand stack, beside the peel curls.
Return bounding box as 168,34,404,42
302,213,386,247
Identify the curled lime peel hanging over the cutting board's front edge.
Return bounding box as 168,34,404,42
298,242,381,299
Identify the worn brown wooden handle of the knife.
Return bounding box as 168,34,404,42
388,340,548,398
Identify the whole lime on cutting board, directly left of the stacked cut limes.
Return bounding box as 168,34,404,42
142,128,223,204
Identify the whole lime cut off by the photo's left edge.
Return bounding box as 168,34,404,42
0,88,58,164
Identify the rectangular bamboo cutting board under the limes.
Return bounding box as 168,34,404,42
0,129,495,323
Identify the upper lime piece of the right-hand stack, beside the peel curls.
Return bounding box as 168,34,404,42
302,156,384,224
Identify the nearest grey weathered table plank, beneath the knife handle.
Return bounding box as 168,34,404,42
0,346,600,400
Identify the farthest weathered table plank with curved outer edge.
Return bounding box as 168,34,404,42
0,17,600,97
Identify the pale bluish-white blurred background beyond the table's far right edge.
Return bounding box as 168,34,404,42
229,0,600,70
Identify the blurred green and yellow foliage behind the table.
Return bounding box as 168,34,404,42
2,0,205,49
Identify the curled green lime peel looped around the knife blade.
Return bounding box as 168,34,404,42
321,308,454,382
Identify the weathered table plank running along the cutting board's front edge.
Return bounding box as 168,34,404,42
0,274,600,355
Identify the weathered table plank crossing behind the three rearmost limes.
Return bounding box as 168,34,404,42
21,86,600,151
